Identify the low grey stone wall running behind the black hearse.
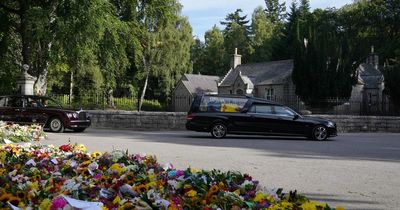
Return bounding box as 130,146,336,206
89,110,400,132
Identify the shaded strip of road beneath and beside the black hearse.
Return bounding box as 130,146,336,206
57,129,400,162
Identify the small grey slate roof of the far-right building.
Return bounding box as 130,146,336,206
358,63,383,89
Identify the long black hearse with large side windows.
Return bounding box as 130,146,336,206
186,95,337,141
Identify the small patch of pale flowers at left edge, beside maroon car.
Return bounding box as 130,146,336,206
0,121,46,144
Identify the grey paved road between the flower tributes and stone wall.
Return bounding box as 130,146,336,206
44,129,400,210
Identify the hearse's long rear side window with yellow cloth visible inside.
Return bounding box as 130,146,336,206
199,96,248,112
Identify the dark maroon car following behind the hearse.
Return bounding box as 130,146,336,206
0,95,91,132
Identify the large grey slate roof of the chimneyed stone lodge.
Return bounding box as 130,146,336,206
220,60,293,86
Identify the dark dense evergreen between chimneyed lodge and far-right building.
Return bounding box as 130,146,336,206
292,9,357,107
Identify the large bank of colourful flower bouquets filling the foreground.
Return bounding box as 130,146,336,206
0,144,342,210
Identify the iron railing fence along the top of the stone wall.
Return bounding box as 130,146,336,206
0,90,400,116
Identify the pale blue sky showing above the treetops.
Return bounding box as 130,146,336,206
180,0,352,40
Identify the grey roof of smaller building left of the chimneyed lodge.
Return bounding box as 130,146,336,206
181,74,220,94
